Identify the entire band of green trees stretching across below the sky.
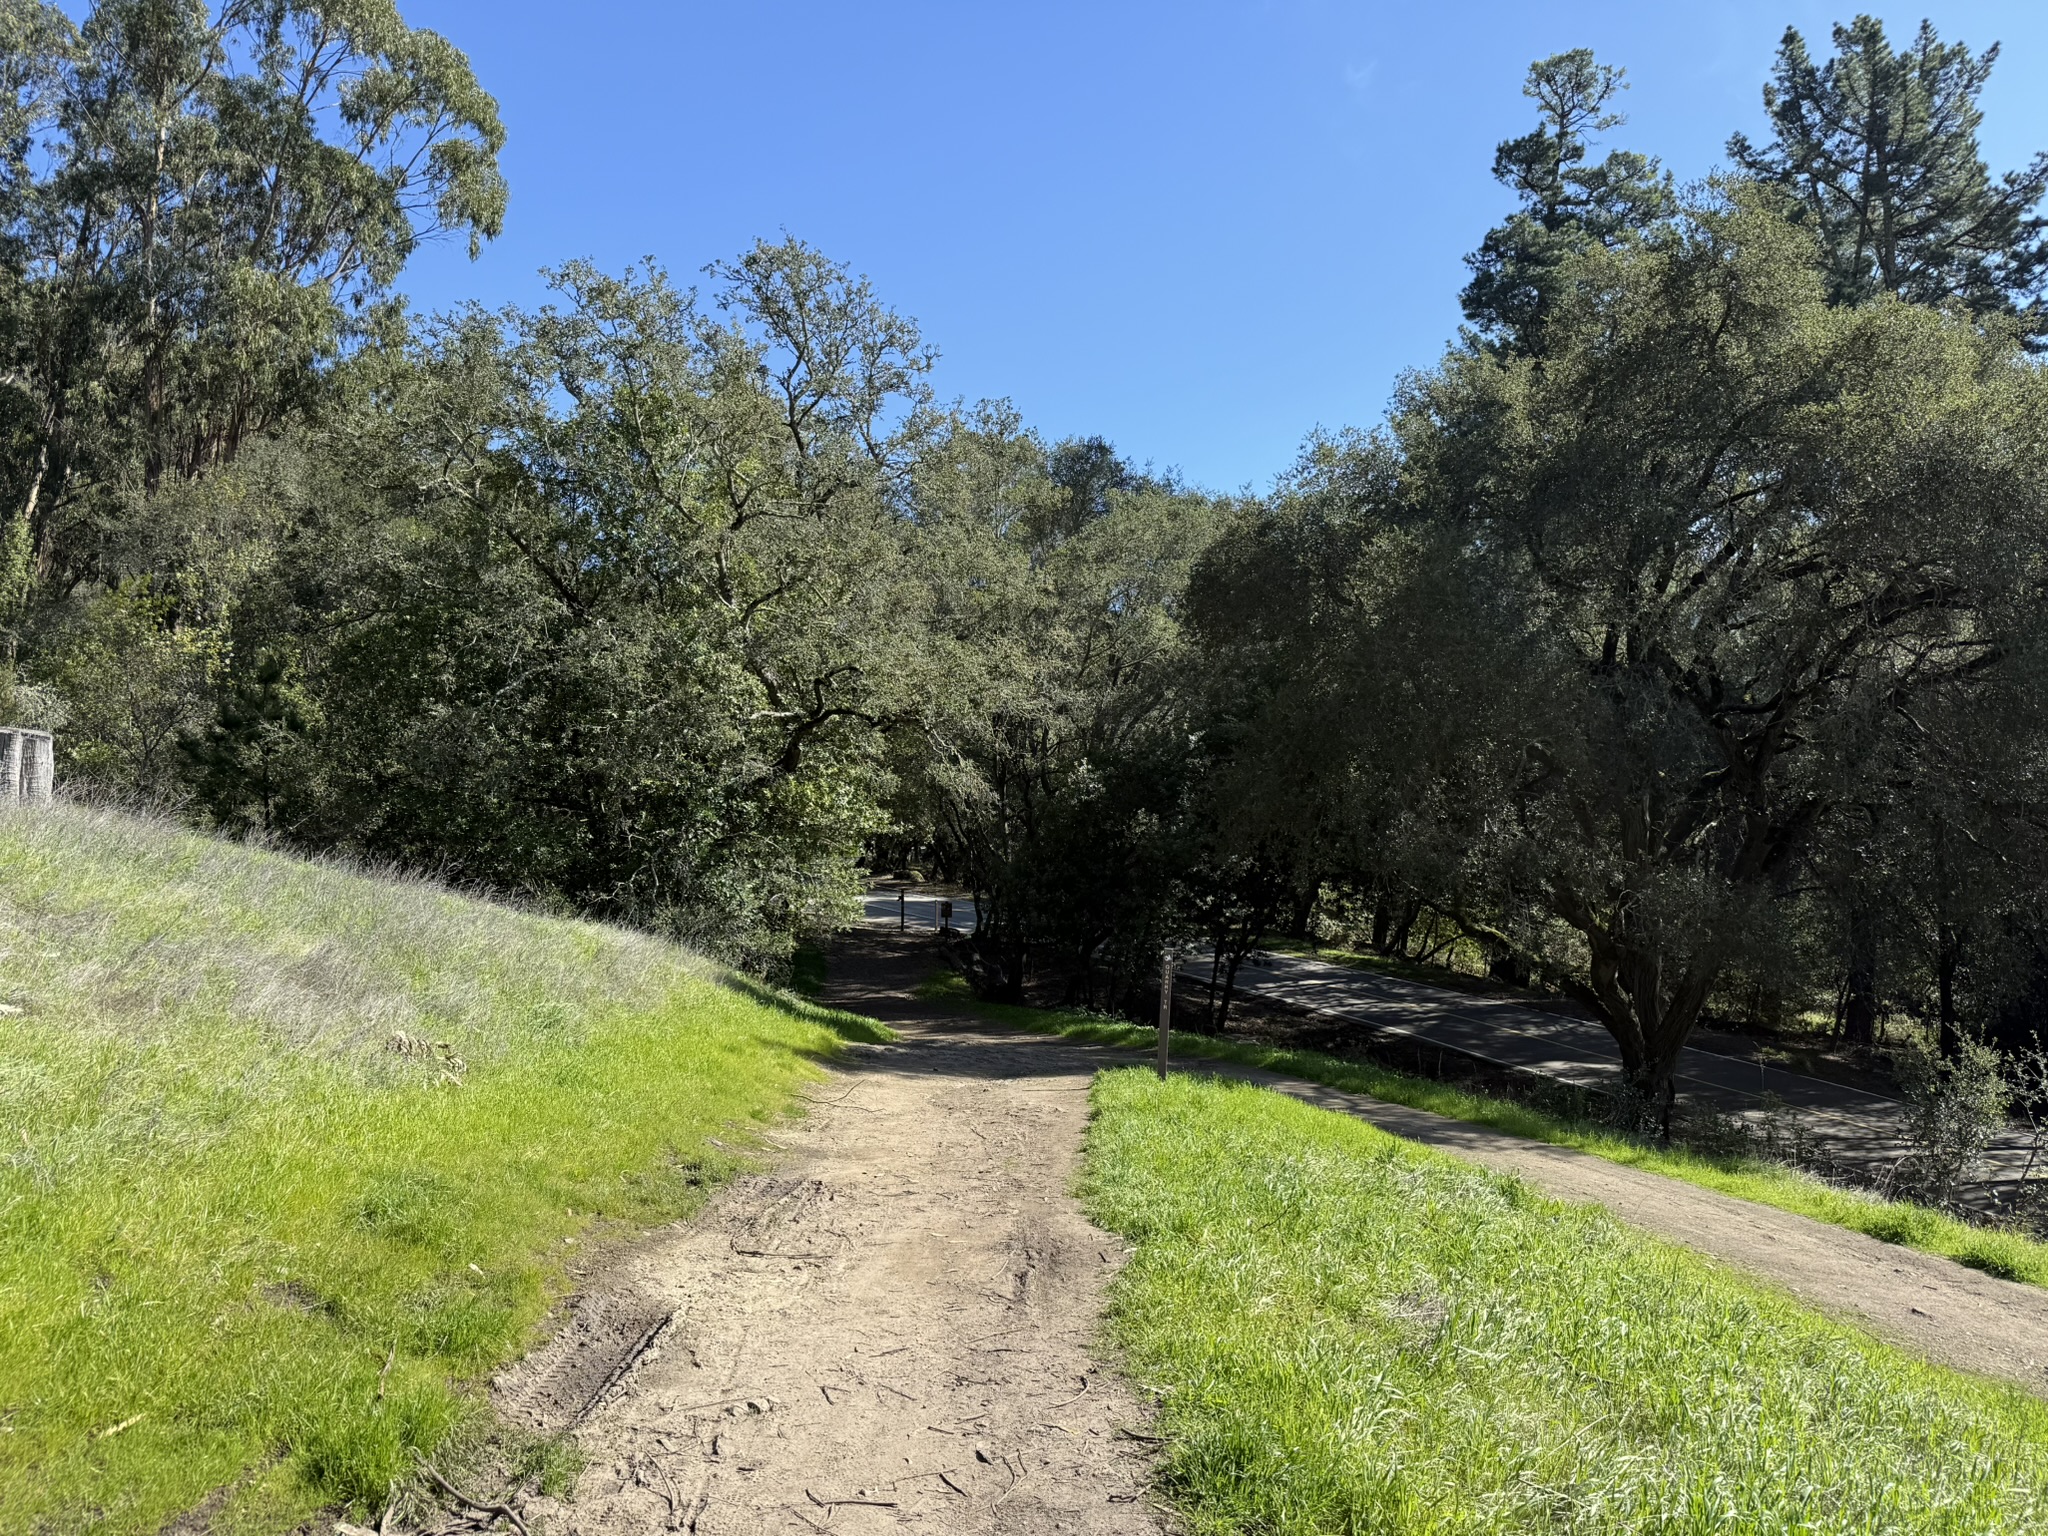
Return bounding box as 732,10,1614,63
0,0,2048,1114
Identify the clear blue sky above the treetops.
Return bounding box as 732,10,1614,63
401,0,2048,489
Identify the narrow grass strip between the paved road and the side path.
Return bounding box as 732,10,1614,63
926,975,2048,1286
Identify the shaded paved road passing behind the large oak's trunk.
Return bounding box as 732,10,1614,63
1180,954,2028,1184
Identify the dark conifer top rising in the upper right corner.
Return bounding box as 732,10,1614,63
1729,16,2048,334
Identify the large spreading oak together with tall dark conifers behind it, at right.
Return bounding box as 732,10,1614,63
1190,18,2048,1122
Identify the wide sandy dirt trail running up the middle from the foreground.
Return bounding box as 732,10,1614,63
496,934,1167,1536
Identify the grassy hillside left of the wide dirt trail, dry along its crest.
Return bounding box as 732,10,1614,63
0,807,874,1532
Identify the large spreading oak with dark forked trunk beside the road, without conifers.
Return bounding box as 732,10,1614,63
1192,186,2048,1104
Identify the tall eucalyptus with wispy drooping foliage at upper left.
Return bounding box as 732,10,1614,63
0,0,506,638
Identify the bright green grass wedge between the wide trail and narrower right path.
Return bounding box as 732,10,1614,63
1083,1069,2048,1536
